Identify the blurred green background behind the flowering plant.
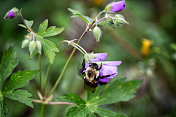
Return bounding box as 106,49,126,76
0,0,176,117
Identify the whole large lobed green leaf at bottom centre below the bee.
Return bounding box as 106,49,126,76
58,78,141,117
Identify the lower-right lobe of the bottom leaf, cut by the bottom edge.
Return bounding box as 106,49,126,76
96,108,127,117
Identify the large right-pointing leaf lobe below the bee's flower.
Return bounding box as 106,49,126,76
97,78,142,105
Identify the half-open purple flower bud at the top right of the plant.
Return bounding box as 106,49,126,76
105,0,126,13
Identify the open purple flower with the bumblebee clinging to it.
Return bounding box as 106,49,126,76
84,53,122,85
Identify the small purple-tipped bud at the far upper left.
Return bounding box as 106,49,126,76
4,7,19,19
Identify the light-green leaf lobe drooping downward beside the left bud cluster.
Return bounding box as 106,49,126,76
38,37,59,64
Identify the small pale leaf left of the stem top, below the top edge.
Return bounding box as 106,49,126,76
68,8,93,24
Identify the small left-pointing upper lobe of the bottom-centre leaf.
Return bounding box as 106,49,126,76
58,93,86,105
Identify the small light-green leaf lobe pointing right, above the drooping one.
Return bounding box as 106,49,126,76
40,26,64,37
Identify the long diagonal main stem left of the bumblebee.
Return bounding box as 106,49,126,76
51,20,95,94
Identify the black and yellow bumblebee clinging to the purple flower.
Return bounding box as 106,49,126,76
81,59,113,92
